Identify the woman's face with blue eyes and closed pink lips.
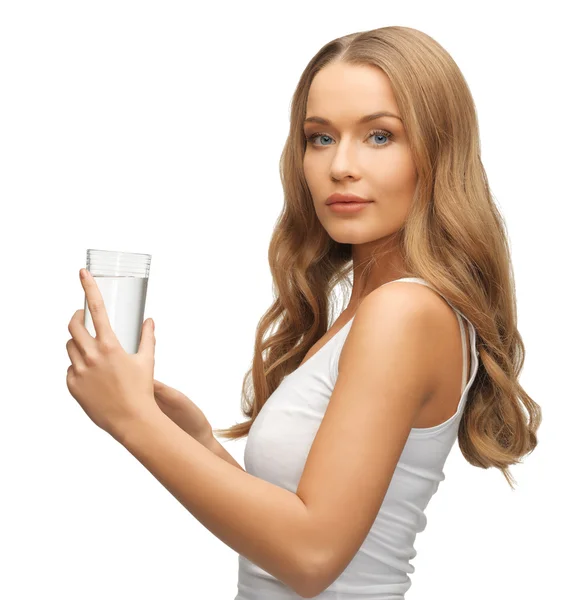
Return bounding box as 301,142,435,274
303,63,417,244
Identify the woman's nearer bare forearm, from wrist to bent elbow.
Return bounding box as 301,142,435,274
118,411,319,595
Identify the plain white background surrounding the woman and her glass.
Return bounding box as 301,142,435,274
0,0,575,600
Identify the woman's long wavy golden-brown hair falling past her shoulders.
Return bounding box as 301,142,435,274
213,27,541,489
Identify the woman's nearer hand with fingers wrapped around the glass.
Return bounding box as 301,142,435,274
66,269,161,439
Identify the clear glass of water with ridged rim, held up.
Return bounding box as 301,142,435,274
84,249,152,354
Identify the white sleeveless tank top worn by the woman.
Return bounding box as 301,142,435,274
235,277,479,600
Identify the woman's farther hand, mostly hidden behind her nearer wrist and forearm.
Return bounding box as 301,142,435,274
154,379,213,445
